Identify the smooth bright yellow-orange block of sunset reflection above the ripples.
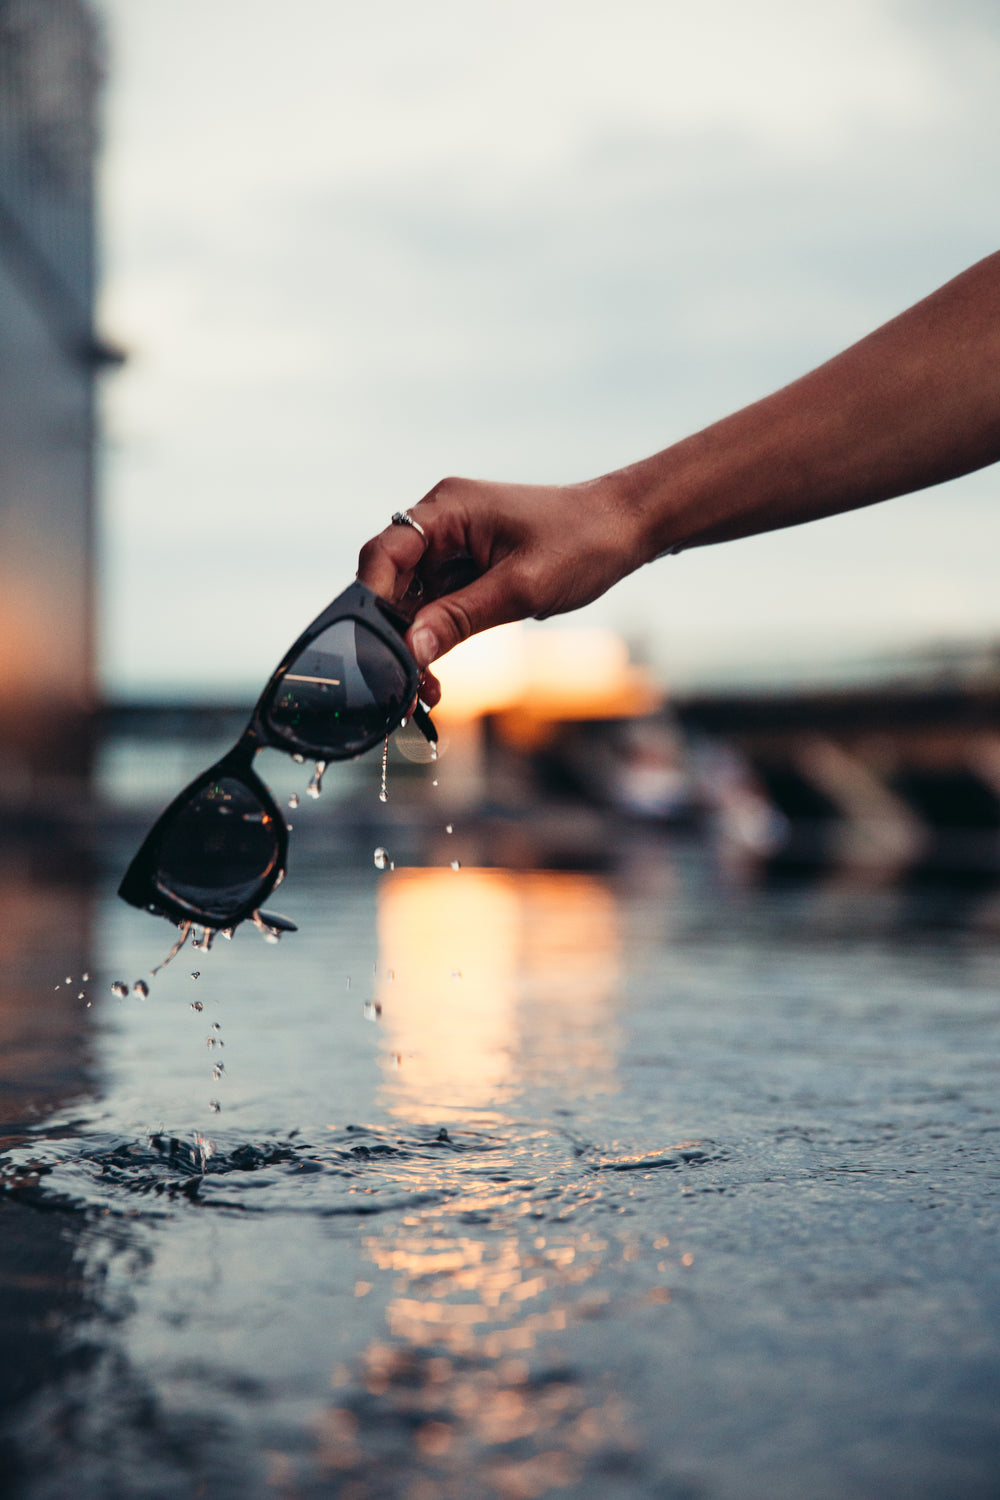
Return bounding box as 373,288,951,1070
376,870,621,1124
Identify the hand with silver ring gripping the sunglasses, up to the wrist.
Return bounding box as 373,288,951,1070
358,477,648,702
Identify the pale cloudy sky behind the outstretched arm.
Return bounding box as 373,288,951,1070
93,0,1000,696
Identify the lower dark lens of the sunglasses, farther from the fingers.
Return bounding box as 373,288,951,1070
154,776,279,924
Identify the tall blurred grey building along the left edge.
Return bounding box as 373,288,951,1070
0,0,114,804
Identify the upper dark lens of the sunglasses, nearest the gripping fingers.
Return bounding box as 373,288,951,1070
264,620,409,759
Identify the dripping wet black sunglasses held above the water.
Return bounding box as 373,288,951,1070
118,584,438,930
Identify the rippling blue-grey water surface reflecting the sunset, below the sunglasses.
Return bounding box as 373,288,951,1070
0,827,1000,1500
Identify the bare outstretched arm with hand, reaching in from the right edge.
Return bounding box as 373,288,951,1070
358,254,1000,681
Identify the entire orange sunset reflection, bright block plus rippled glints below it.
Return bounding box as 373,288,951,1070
296,870,634,1500
